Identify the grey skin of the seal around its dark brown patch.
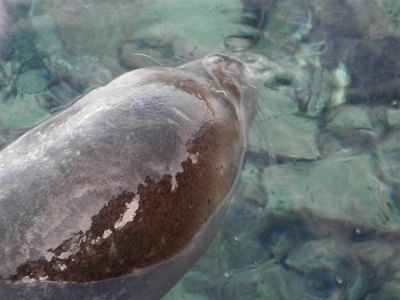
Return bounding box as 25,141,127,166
0,55,257,299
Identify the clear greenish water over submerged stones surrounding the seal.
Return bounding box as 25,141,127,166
0,0,400,300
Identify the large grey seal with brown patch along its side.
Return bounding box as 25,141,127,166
0,54,257,300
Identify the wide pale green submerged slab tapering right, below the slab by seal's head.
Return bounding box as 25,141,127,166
263,155,399,228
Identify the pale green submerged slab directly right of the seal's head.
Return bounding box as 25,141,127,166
249,87,319,160
